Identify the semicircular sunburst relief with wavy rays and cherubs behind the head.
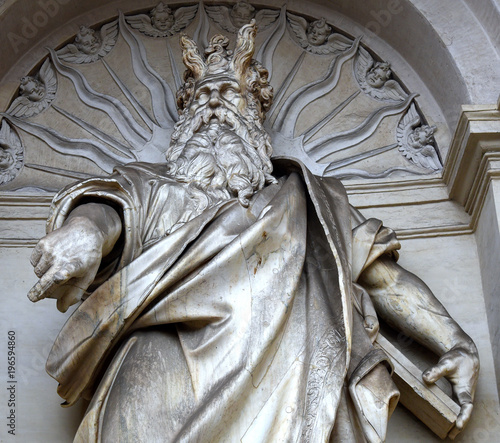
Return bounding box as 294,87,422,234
0,0,442,191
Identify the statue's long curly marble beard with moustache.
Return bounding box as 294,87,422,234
166,107,276,210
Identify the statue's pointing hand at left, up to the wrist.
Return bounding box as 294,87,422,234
28,217,104,312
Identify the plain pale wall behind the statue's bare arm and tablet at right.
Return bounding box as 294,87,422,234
387,235,500,443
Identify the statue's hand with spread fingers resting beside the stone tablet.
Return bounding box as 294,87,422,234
422,341,479,434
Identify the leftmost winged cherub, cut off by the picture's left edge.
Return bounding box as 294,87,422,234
0,120,24,185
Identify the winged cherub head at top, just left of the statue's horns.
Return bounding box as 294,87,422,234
127,2,198,37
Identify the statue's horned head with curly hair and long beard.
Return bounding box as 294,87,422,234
166,20,274,210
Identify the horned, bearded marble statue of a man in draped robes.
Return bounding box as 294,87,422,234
29,23,479,443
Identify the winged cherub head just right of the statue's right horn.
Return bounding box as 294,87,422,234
286,12,352,55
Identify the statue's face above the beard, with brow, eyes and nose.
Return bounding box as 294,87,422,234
189,76,246,119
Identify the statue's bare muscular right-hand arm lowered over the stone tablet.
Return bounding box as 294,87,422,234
358,256,479,430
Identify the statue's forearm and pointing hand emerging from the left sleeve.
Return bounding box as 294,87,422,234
28,203,122,312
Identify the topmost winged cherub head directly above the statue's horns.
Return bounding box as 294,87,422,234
205,0,280,34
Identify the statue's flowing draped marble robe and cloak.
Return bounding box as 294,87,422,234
47,162,399,443
